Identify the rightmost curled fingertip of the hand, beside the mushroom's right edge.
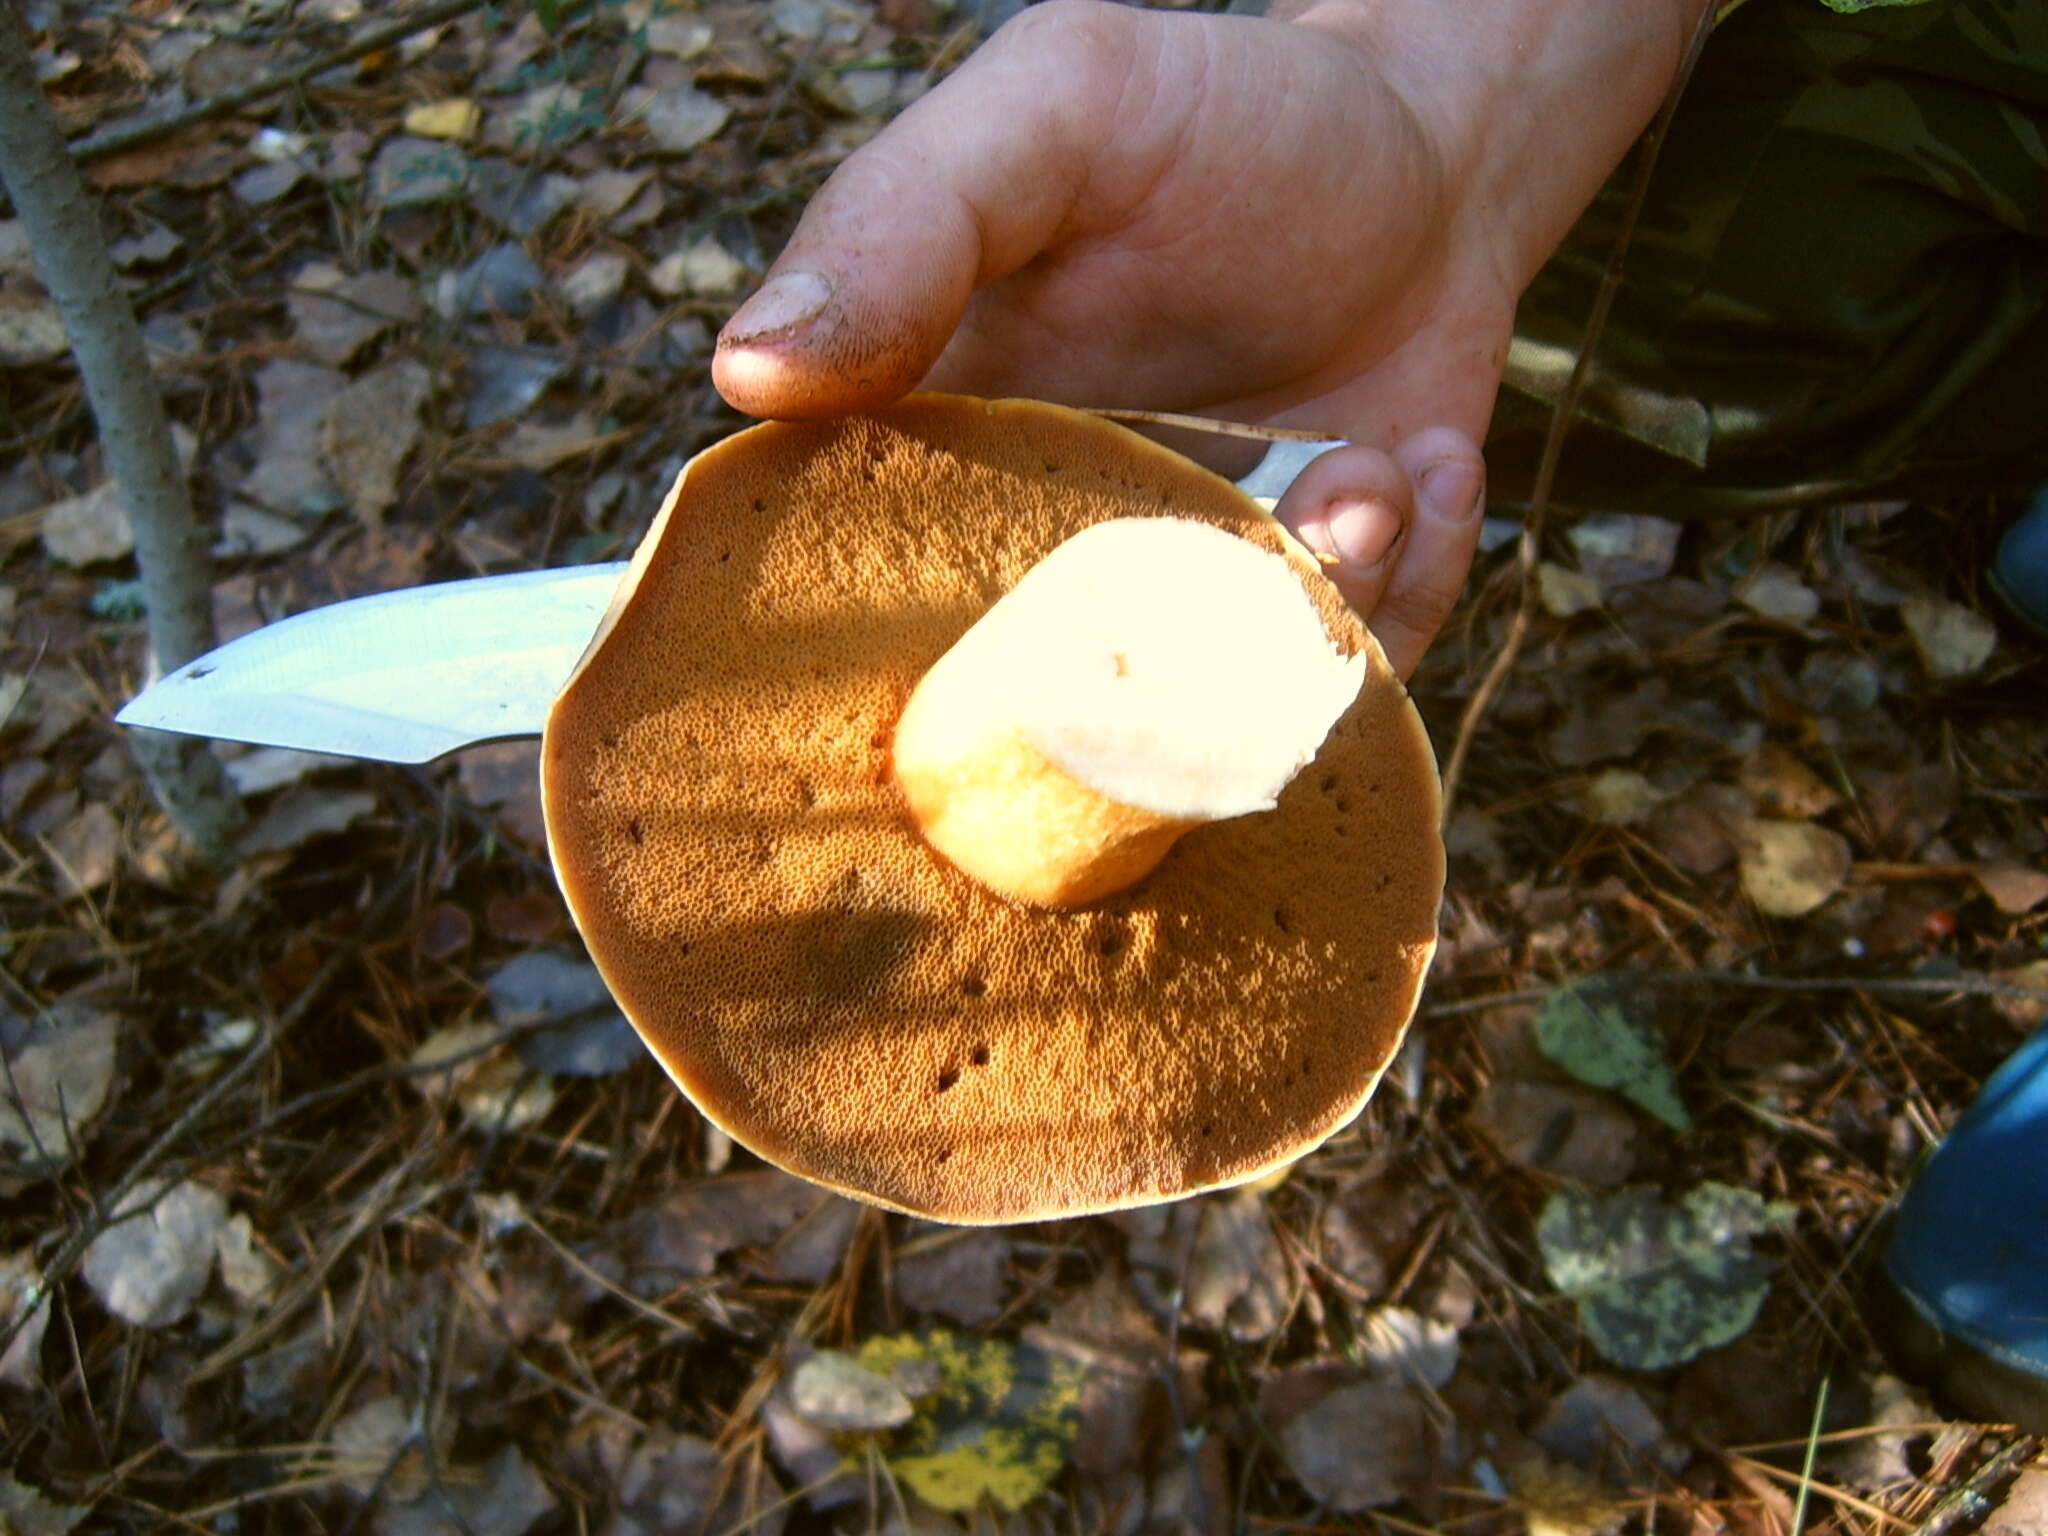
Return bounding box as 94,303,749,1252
1366,426,1487,678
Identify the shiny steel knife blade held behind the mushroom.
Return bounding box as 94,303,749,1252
115,440,1343,762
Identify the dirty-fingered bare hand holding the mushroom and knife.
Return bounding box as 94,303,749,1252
713,0,1696,676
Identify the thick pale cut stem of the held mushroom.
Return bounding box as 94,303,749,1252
893,518,1366,907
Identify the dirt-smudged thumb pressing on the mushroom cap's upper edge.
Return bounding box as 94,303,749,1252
711,4,1141,418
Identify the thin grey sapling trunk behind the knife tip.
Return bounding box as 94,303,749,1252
0,4,240,862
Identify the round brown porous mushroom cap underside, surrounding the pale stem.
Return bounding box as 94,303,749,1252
541,395,1444,1223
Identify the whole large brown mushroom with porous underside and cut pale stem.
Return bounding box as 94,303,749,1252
543,395,1444,1223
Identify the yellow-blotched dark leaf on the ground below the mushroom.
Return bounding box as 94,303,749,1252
850,1329,1081,1511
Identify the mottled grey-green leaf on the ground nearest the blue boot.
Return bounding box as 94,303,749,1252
1536,1184,1796,1370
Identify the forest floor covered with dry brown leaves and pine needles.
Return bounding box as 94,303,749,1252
0,0,2048,1536
